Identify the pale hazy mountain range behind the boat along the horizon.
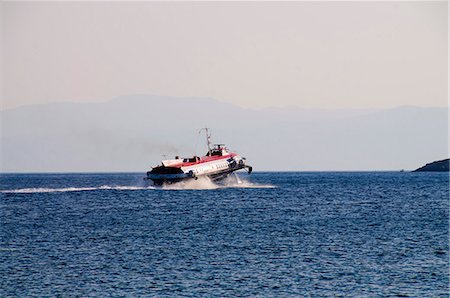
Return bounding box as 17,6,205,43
0,95,448,172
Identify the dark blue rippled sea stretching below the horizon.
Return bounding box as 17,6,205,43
0,173,449,297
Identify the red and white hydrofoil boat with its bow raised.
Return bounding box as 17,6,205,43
144,128,253,186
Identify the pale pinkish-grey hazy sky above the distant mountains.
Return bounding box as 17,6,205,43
0,2,448,108
